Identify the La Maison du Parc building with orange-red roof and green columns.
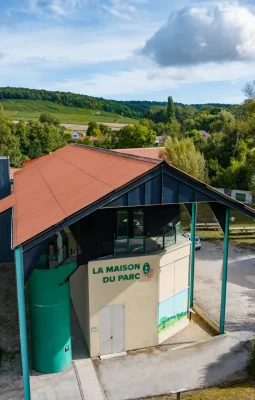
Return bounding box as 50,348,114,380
0,144,255,400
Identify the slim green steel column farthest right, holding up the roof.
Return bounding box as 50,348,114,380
220,207,230,335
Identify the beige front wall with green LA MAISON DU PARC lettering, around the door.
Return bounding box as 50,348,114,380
88,237,190,357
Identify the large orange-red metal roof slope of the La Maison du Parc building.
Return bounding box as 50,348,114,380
3,145,158,247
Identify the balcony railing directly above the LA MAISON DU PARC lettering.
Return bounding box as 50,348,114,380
114,228,178,255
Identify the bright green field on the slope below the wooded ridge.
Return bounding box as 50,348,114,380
0,100,136,125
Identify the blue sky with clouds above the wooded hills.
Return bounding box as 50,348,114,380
0,0,255,104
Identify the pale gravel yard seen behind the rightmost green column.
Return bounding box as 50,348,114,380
194,242,255,334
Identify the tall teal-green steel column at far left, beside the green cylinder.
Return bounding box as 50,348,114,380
15,247,31,400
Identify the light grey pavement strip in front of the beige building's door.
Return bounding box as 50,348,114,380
98,336,253,400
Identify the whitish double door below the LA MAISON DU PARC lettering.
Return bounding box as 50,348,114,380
99,304,125,354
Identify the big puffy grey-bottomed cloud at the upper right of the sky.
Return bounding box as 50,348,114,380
141,3,255,67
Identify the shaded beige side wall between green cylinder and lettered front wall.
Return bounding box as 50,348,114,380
70,265,90,348
